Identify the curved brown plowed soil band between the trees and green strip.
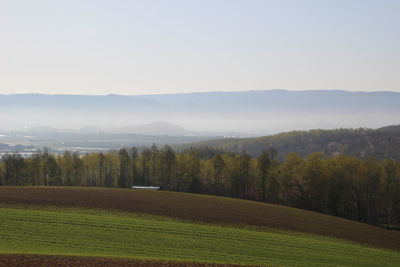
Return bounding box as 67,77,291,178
0,187,400,250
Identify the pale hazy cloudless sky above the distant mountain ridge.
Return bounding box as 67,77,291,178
0,0,400,94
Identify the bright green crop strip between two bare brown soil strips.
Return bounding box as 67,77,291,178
0,205,400,266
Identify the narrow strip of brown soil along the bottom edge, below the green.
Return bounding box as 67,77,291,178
0,254,253,267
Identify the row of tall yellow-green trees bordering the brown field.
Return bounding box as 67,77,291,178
0,145,400,226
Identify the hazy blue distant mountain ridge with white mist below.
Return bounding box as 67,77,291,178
0,90,400,134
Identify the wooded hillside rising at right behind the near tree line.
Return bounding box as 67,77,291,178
187,125,400,159
